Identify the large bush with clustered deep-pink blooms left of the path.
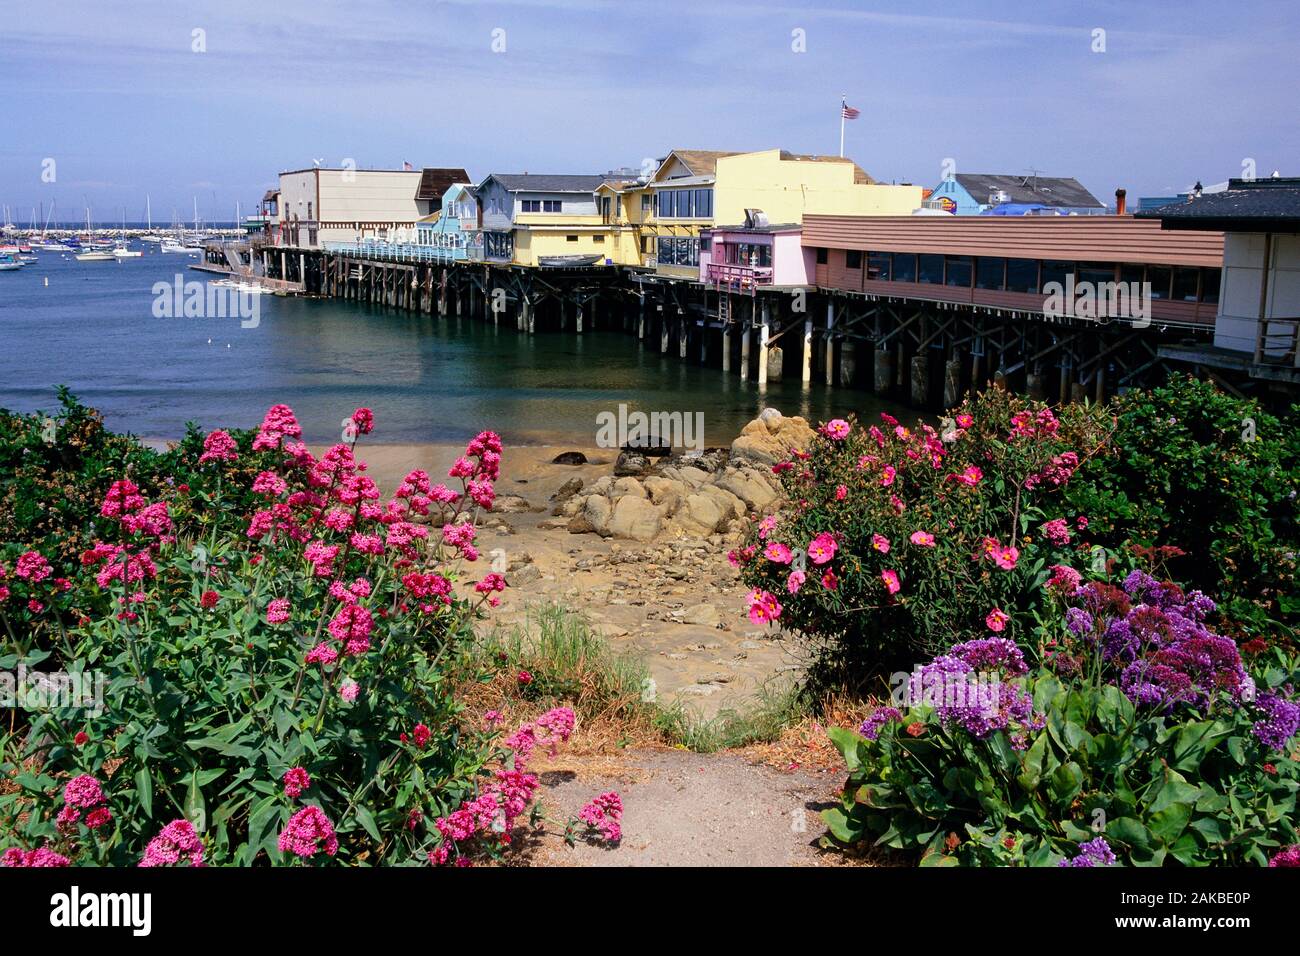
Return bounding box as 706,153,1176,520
0,406,527,866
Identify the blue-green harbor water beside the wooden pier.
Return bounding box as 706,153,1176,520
0,247,887,446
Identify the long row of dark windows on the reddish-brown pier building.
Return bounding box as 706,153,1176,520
816,248,1219,303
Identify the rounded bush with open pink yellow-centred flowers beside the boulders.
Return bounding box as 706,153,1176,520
732,389,1106,682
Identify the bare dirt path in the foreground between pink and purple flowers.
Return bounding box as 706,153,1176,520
520,750,844,866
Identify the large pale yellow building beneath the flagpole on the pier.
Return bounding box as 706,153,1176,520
639,150,922,278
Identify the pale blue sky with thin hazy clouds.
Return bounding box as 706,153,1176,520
0,0,1300,225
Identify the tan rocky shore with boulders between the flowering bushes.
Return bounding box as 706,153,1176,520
363,408,814,715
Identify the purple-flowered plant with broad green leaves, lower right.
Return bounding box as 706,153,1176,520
823,572,1300,866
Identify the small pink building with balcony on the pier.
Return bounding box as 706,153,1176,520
699,209,816,291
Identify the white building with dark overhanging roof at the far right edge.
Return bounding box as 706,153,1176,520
1138,176,1300,384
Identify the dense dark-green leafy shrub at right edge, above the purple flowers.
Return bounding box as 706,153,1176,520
1066,376,1300,633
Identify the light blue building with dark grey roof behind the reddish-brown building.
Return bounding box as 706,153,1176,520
926,173,1108,216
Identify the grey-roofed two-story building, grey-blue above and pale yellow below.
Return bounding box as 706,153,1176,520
475,173,610,265
